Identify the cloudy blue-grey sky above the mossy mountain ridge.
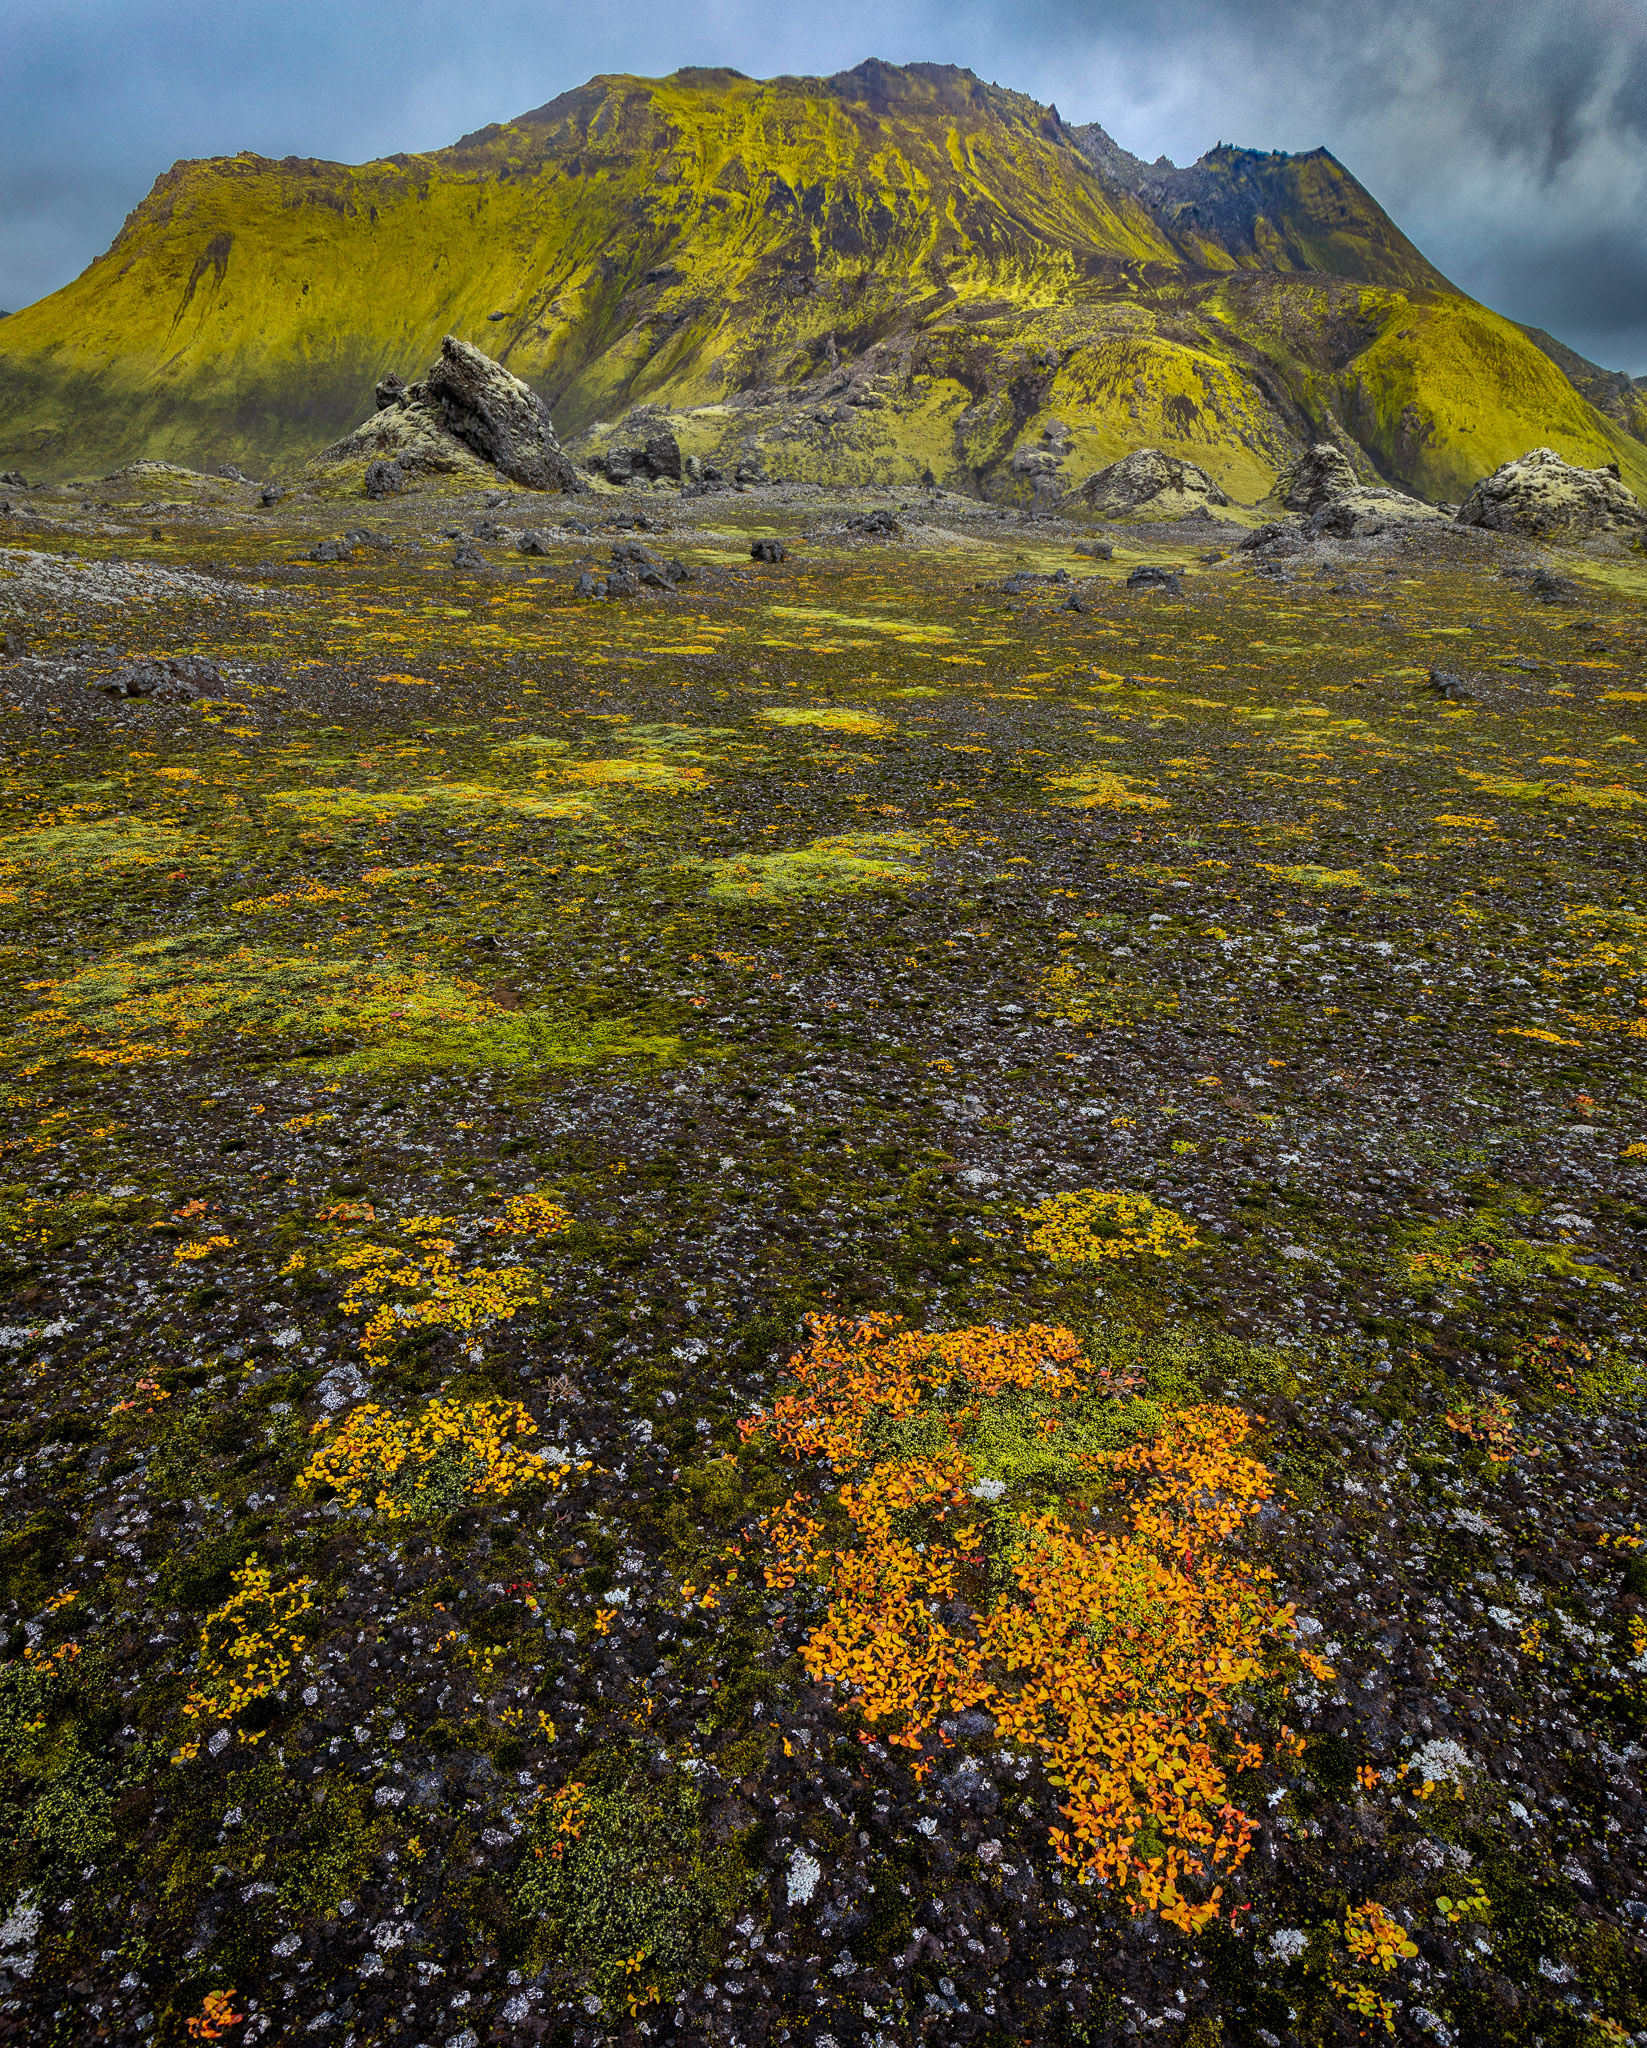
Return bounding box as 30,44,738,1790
0,0,1647,375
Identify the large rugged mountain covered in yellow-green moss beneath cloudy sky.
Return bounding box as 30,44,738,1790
0,61,1647,502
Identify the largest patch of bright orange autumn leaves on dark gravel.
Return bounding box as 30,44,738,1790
746,1317,1315,1931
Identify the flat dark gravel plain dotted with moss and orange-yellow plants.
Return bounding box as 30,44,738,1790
0,485,1647,2048
